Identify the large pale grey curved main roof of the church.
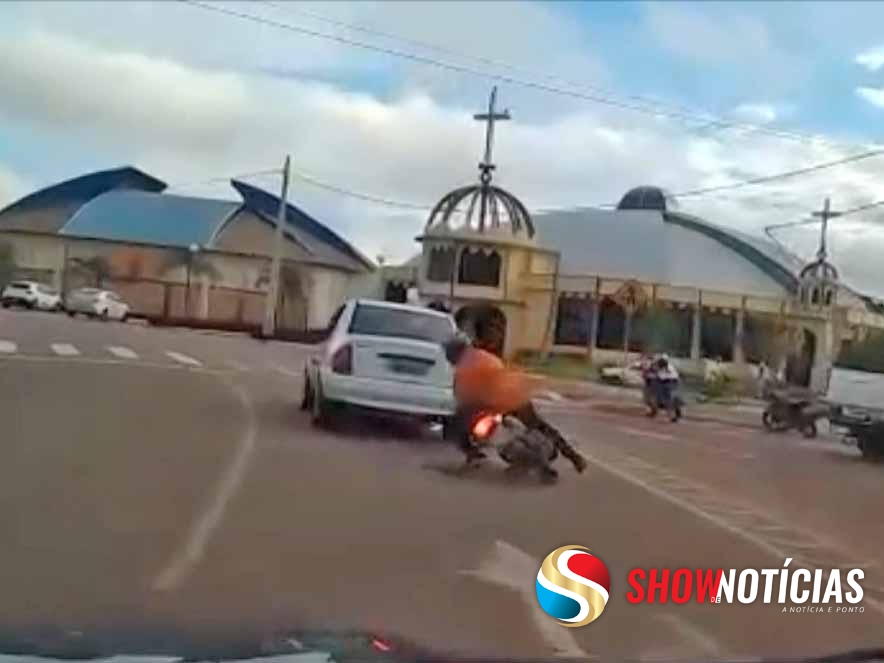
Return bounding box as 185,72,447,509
534,208,800,296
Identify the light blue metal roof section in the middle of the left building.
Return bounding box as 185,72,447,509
59,191,240,246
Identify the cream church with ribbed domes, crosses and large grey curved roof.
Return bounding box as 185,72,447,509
382,91,884,390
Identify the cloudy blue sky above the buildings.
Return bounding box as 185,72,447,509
0,0,884,295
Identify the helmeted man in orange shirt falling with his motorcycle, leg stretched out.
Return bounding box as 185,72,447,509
444,334,586,473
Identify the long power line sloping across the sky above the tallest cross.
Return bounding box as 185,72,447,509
179,0,864,147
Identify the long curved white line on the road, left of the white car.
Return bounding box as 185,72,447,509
153,381,258,591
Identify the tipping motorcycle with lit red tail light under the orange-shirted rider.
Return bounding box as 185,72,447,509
470,412,559,481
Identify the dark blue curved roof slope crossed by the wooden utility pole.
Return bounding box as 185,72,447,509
230,180,374,270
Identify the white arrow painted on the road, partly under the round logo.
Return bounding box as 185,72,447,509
460,541,588,659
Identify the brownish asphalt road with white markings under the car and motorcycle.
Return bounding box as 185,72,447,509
0,311,884,660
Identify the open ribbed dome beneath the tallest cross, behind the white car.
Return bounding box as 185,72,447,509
426,183,534,239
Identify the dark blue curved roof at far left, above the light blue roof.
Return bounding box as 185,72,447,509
0,166,166,230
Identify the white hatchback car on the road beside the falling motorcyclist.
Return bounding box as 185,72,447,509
301,299,457,425
